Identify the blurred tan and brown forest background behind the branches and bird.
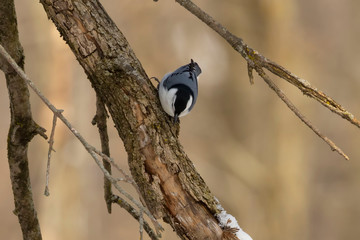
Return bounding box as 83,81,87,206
0,0,360,240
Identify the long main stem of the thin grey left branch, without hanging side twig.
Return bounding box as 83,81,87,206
0,44,163,236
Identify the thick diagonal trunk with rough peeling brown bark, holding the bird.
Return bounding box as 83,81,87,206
40,0,223,240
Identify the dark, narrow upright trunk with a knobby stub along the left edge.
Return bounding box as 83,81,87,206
0,0,45,240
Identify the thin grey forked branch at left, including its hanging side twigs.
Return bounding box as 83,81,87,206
0,45,163,240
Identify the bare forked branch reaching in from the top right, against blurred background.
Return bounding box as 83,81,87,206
175,0,360,160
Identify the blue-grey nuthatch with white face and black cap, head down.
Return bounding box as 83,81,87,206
158,59,201,122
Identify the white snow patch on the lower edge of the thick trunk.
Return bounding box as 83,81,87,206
215,199,252,240
